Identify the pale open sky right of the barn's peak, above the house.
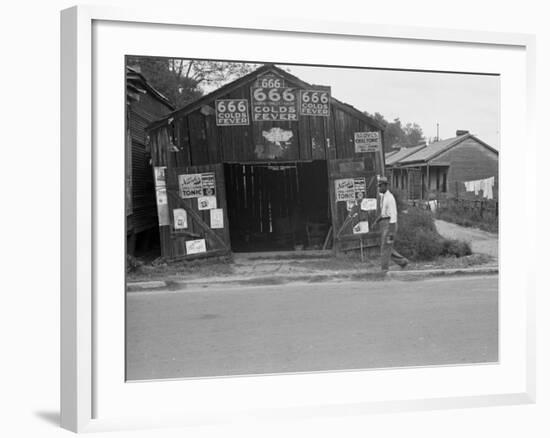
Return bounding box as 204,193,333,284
286,65,500,149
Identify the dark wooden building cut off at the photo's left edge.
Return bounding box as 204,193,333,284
126,67,174,254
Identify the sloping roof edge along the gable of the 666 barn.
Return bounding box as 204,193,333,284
148,64,386,130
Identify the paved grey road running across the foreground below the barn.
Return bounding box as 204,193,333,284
127,276,498,380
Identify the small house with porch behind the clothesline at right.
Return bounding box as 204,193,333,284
386,131,498,200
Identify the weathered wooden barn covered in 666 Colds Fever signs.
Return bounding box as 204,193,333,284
148,65,384,259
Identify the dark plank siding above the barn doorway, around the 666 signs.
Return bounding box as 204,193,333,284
150,72,383,168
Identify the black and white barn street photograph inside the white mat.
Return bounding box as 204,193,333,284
125,55,501,381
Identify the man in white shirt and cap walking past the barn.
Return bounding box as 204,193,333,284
374,176,409,272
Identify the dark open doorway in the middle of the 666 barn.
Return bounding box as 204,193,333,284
225,160,331,252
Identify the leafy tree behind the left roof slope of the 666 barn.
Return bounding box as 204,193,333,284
127,56,257,108
